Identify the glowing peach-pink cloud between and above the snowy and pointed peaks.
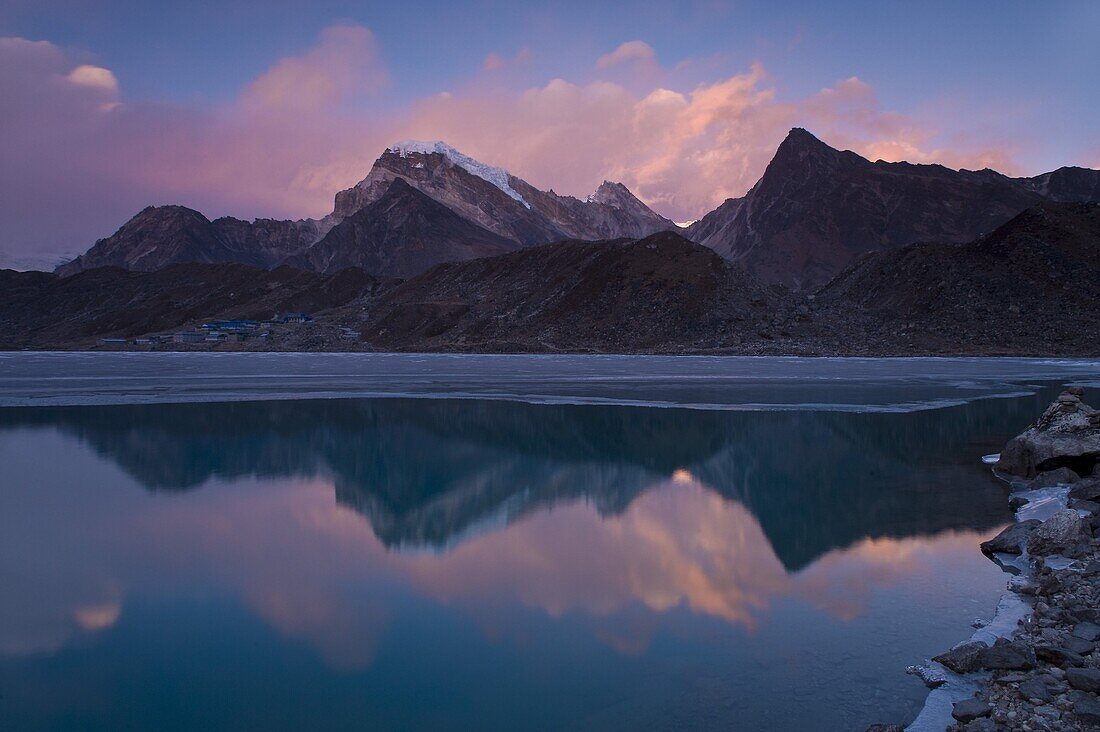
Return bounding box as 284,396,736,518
404,64,1029,220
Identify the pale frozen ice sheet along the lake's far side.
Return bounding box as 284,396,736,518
0,352,1100,412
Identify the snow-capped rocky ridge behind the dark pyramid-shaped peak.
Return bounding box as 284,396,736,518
333,141,675,247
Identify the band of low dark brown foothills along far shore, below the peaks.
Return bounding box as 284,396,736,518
0,200,1100,356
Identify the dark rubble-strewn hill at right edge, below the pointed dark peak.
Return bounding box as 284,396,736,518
816,203,1100,354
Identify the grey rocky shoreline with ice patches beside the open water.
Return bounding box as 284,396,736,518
869,387,1100,732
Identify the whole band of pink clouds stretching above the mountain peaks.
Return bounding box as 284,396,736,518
0,25,1029,266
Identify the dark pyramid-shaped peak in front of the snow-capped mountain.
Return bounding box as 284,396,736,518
288,178,517,277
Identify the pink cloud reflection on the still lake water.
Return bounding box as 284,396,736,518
0,436,1003,668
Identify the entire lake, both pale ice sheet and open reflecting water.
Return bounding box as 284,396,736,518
0,353,1100,730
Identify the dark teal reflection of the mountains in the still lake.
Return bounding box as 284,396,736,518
0,395,1029,569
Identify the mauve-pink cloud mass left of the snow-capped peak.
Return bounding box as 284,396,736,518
0,25,393,267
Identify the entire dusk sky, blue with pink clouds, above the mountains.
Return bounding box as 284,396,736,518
0,0,1100,269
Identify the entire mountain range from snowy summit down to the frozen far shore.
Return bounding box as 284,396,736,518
0,129,1100,356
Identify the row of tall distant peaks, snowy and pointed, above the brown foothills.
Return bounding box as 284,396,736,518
51,129,1100,292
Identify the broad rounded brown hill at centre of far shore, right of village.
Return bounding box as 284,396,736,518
362,232,783,351
